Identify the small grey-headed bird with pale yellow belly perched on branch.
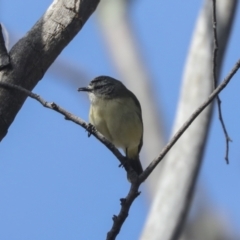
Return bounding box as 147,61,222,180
78,76,143,175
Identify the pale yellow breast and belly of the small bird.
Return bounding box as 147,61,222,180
89,98,143,157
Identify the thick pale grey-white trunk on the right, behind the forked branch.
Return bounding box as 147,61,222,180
141,0,237,240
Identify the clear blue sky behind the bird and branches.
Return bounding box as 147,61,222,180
0,0,240,240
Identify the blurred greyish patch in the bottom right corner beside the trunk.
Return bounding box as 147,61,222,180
180,188,240,240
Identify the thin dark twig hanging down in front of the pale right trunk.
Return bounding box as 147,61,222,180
212,0,232,164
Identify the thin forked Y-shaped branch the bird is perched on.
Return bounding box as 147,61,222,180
0,60,240,240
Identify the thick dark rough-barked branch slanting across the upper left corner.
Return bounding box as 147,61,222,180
0,0,100,141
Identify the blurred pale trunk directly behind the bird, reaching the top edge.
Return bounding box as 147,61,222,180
97,0,166,198
